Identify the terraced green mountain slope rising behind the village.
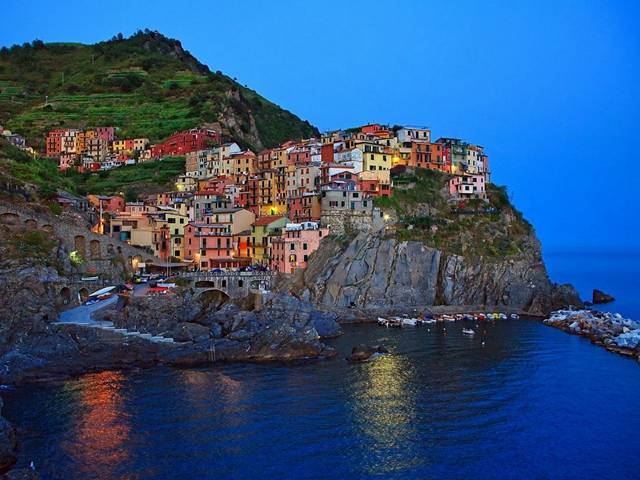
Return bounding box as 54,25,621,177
0,30,318,150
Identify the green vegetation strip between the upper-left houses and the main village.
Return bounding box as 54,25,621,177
0,140,184,200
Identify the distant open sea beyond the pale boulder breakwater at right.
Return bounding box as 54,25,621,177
544,249,640,320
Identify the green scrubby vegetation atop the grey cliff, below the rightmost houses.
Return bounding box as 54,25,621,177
376,169,532,258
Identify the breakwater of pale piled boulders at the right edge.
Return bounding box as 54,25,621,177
544,310,640,360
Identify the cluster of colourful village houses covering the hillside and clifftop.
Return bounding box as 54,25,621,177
0,124,489,273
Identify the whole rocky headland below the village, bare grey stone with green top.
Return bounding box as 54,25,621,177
296,170,582,314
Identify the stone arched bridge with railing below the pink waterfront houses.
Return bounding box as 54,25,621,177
180,272,275,298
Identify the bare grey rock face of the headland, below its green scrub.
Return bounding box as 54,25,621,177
304,233,581,314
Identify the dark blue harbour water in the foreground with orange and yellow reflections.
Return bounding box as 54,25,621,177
5,320,640,479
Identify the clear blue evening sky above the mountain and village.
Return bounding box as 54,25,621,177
0,0,640,249
